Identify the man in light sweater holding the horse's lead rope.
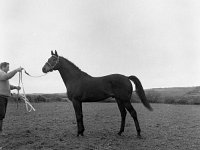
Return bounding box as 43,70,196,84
0,62,23,135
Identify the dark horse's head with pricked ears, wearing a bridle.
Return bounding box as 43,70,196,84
42,50,60,73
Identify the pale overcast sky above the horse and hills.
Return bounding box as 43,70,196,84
0,0,200,93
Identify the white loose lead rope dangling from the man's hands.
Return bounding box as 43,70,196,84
17,71,35,112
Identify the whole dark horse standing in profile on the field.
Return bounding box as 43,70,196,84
42,51,152,137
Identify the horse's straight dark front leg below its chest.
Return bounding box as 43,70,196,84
72,100,85,136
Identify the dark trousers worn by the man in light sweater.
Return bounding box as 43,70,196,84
0,95,8,120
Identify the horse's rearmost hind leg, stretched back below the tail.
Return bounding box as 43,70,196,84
124,102,141,138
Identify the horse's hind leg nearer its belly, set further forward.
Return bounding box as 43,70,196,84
116,99,127,135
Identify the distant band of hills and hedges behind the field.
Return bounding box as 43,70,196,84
9,86,200,105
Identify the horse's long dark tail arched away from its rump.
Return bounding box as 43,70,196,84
128,76,153,111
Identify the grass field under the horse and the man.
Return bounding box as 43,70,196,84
0,102,200,150
